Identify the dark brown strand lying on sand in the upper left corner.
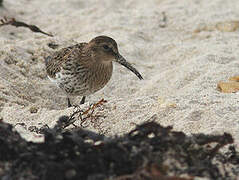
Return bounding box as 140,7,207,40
0,17,53,37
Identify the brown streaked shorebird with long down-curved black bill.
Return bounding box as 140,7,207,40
45,36,143,107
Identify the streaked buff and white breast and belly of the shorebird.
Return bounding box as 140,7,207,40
49,63,113,96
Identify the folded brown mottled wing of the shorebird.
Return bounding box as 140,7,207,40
45,43,87,78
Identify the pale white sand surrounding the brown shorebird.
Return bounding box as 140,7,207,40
0,0,239,144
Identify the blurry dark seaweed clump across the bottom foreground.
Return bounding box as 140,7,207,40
0,117,239,180
